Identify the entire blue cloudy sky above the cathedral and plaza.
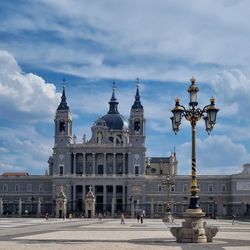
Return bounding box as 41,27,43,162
0,0,250,175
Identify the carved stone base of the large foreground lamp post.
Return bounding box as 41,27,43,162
170,208,218,243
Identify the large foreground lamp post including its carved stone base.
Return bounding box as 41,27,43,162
170,77,219,243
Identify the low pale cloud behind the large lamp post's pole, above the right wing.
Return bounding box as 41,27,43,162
177,135,250,175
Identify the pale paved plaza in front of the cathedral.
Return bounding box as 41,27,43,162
0,218,250,250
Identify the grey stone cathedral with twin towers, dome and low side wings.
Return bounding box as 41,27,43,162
0,81,250,217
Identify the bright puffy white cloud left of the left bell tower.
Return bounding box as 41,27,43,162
0,51,60,122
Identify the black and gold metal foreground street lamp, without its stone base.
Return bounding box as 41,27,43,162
170,77,219,209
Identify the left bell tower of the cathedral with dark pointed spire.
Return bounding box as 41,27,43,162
54,86,72,147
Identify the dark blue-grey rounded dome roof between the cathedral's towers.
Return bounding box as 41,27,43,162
101,113,128,130
